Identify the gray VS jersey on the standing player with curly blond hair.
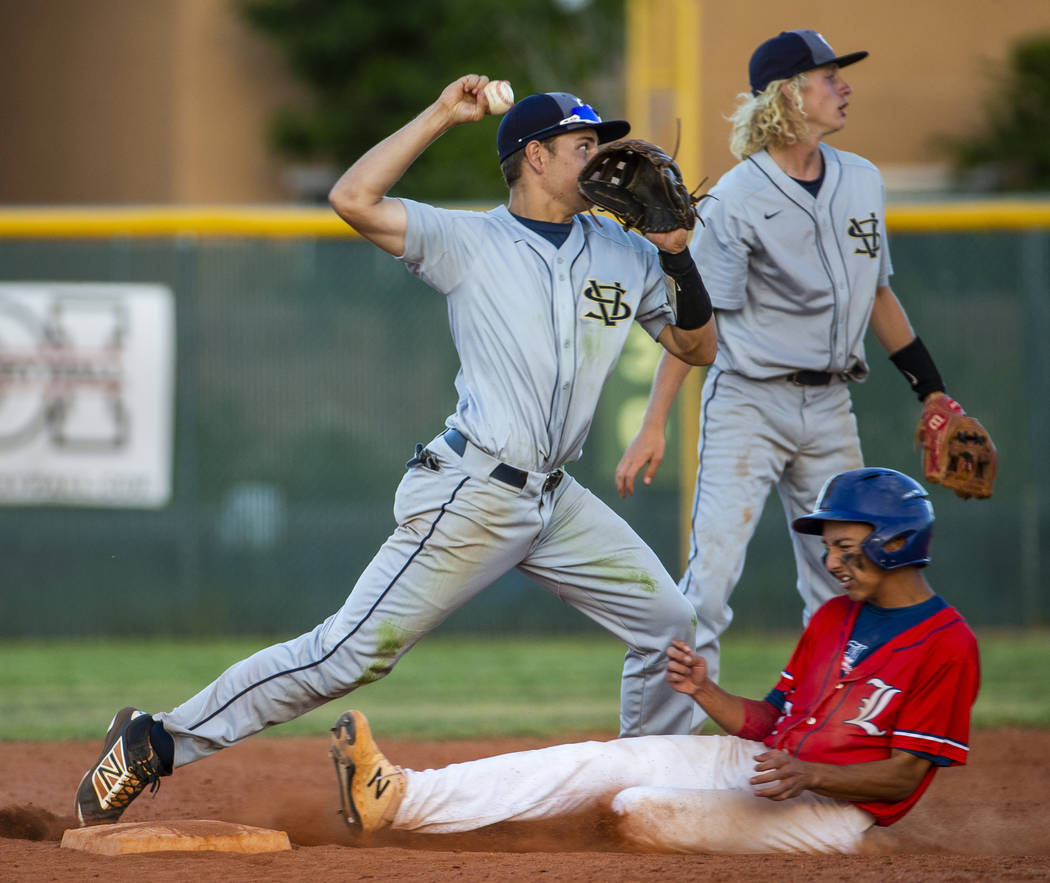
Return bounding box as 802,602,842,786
691,144,893,380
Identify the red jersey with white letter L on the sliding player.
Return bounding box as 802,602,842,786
764,595,981,825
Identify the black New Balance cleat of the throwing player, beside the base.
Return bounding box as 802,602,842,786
74,707,171,826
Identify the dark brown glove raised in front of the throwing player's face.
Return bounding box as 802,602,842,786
579,140,706,233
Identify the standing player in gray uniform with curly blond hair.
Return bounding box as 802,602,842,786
616,30,974,727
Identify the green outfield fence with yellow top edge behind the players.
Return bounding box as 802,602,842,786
0,202,1050,637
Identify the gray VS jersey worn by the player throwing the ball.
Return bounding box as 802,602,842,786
402,199,674,471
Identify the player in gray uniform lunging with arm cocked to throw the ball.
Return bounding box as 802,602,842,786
76,75,716,824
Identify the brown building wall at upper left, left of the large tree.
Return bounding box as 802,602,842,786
0,0,298,204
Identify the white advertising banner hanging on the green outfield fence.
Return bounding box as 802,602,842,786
0,282,175,508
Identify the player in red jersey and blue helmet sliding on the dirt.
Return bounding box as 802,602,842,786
331,468,980,853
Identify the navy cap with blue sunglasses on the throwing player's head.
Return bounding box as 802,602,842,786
496,92,631,163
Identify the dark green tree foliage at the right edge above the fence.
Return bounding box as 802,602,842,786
950,34,1050,191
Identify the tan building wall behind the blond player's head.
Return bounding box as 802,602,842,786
627,0,1050,191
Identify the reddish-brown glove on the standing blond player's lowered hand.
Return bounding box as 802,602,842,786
916,396,999,500
